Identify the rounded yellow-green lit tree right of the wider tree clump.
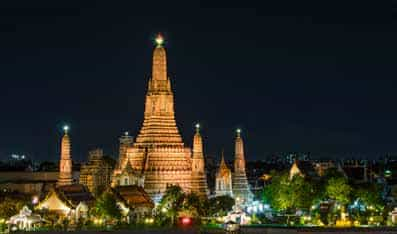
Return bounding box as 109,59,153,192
325,177,353,205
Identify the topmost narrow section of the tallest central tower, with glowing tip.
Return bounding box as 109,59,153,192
152,34,167,80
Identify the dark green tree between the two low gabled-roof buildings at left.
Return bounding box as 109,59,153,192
93,192,121,221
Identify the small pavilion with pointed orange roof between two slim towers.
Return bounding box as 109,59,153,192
215,150,233,197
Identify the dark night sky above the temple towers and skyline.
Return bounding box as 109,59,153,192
0,1,397,160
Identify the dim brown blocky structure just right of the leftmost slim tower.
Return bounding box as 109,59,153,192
80,149,113,196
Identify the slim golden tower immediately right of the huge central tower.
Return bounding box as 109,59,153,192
191,124,208,197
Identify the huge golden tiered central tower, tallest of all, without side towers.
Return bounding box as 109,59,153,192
113,35,192,201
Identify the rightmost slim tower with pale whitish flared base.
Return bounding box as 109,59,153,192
233,129,253,202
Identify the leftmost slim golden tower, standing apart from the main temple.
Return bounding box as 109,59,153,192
57,126,73,186
